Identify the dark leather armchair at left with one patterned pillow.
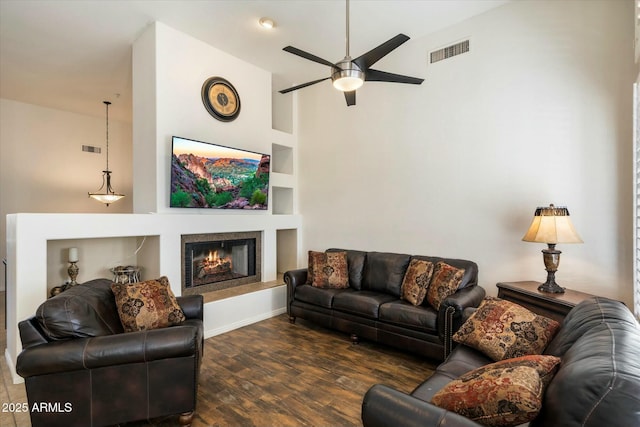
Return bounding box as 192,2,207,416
16,279,203,427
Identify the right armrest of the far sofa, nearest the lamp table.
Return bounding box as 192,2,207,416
438,285,486,357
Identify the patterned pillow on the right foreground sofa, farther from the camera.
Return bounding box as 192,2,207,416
453,297,560,361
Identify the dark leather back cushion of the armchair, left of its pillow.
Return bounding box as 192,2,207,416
36,279,123,340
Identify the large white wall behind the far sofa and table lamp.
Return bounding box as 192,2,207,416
298,1,635,304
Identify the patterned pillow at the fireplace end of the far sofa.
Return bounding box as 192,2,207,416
308,251,349,289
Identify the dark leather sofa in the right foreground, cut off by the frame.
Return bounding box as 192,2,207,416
362,297,640,427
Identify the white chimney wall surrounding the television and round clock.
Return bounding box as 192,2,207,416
134,22,276,214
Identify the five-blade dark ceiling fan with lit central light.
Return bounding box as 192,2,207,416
280,0,424,106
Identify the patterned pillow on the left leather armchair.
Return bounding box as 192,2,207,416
111,276,185,332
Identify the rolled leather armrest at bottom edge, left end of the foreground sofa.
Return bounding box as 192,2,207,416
362,384,480,427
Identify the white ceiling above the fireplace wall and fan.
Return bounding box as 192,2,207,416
0,0,509,121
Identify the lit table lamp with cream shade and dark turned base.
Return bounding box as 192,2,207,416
522,204,582,294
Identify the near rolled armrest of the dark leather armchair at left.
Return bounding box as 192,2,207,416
16,320,203,378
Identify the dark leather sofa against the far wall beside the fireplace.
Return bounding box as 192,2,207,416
284,248,485,361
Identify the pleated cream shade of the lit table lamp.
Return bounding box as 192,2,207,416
522,204,582,244
